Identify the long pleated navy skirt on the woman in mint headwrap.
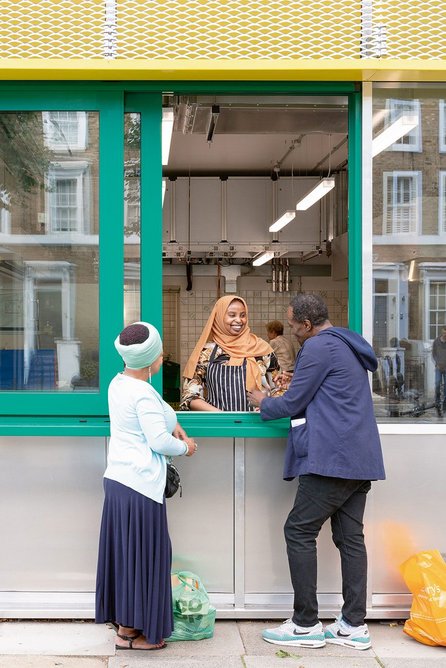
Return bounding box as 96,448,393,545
95,478,173,644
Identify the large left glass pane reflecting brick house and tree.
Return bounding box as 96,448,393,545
0,111,99,392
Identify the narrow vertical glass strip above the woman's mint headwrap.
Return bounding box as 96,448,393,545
124,113,141,325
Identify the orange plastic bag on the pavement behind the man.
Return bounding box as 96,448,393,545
400,550,446,646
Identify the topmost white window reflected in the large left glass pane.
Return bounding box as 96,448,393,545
42,111,87,151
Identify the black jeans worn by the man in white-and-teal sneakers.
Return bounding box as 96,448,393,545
284,475,371,627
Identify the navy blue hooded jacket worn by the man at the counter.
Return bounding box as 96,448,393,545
260,327,385,480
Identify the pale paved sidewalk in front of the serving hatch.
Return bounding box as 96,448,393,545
0,620,446,668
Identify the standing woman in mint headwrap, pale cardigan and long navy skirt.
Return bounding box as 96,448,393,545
96,322,197,650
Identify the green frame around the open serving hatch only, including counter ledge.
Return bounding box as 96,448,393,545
125,82,362,437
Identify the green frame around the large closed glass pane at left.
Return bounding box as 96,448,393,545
0,86,124,419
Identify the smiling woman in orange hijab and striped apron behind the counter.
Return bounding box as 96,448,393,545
181,295,278,411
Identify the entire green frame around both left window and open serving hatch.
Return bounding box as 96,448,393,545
0,81,362,437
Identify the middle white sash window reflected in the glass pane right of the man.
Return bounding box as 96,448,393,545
383,172,421,234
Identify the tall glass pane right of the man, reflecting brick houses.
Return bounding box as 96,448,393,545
373,84,446,422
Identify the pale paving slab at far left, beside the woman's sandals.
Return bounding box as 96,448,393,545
0,622,115,660
